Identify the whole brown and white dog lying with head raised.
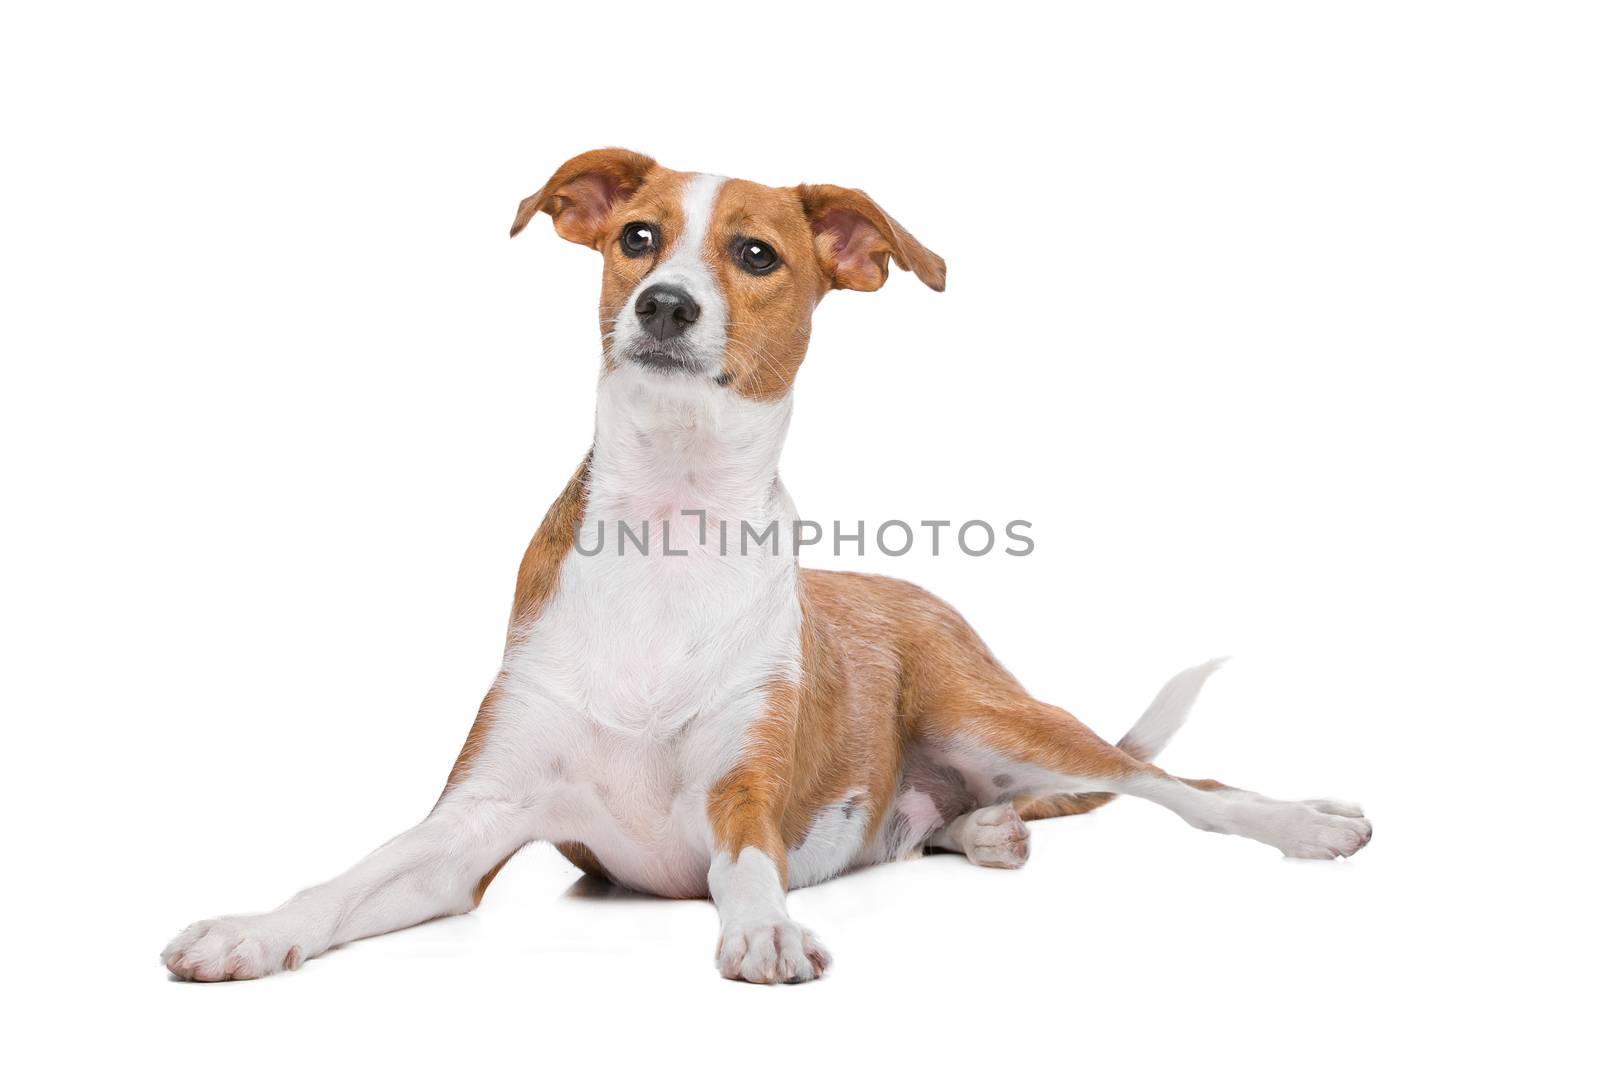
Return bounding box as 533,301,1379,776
162,149,1371,982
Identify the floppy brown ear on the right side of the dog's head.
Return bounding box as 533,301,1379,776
795,186,944,293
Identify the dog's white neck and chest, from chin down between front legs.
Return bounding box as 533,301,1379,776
483,386,800,896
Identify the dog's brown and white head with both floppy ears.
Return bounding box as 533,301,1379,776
510,149,944,400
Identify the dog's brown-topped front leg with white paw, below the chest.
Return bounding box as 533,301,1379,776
707,726,832,982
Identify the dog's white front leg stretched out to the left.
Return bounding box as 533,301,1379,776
162,790,530,982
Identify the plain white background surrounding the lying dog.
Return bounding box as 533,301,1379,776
0,2,1600,1064
